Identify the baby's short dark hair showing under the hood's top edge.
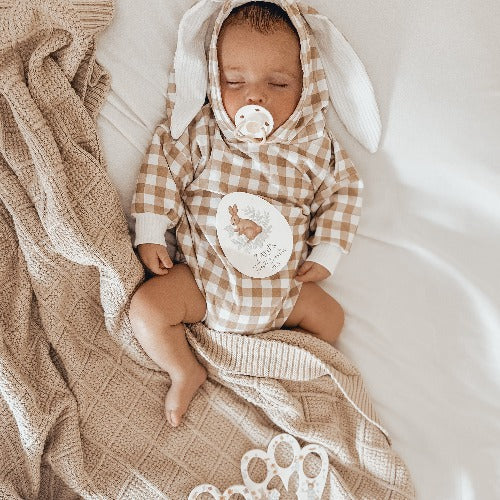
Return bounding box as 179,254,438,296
222,2,297,34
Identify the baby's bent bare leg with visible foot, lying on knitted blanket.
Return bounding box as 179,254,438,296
130,264,207,427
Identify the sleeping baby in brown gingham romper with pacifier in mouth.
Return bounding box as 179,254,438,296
130,1,362,426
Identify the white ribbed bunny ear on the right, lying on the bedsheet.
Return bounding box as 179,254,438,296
303,12,382,153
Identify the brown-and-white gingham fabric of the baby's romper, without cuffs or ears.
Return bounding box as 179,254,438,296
132,1,362,333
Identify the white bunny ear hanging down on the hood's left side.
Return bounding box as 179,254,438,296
170,0,222,139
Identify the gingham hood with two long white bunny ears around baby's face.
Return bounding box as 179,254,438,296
171,0,381,152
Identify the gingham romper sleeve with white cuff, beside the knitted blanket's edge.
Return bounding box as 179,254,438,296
132,122,193,246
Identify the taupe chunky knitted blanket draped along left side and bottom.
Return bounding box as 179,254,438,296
0,0,414,499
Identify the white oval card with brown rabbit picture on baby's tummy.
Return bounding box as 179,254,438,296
215,192,293,278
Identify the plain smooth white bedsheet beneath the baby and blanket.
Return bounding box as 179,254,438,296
94,0,500,500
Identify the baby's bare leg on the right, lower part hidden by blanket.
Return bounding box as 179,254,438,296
284,281,344,344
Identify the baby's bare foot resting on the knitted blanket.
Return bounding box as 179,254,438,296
165,364,207,427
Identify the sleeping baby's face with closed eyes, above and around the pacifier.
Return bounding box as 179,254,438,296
217,24,302,130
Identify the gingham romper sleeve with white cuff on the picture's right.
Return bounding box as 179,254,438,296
307,138,363,272
